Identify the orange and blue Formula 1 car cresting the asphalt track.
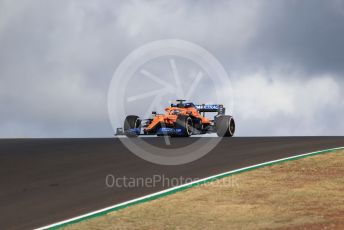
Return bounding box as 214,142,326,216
116,100,235,137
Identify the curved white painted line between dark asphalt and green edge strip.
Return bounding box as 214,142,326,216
35,146,344,230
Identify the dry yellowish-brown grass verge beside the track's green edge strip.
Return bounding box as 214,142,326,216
65,151,344,230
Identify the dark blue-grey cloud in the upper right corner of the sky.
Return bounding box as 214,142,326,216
244,0,344,74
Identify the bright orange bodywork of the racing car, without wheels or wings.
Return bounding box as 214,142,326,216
145,107,211,132
